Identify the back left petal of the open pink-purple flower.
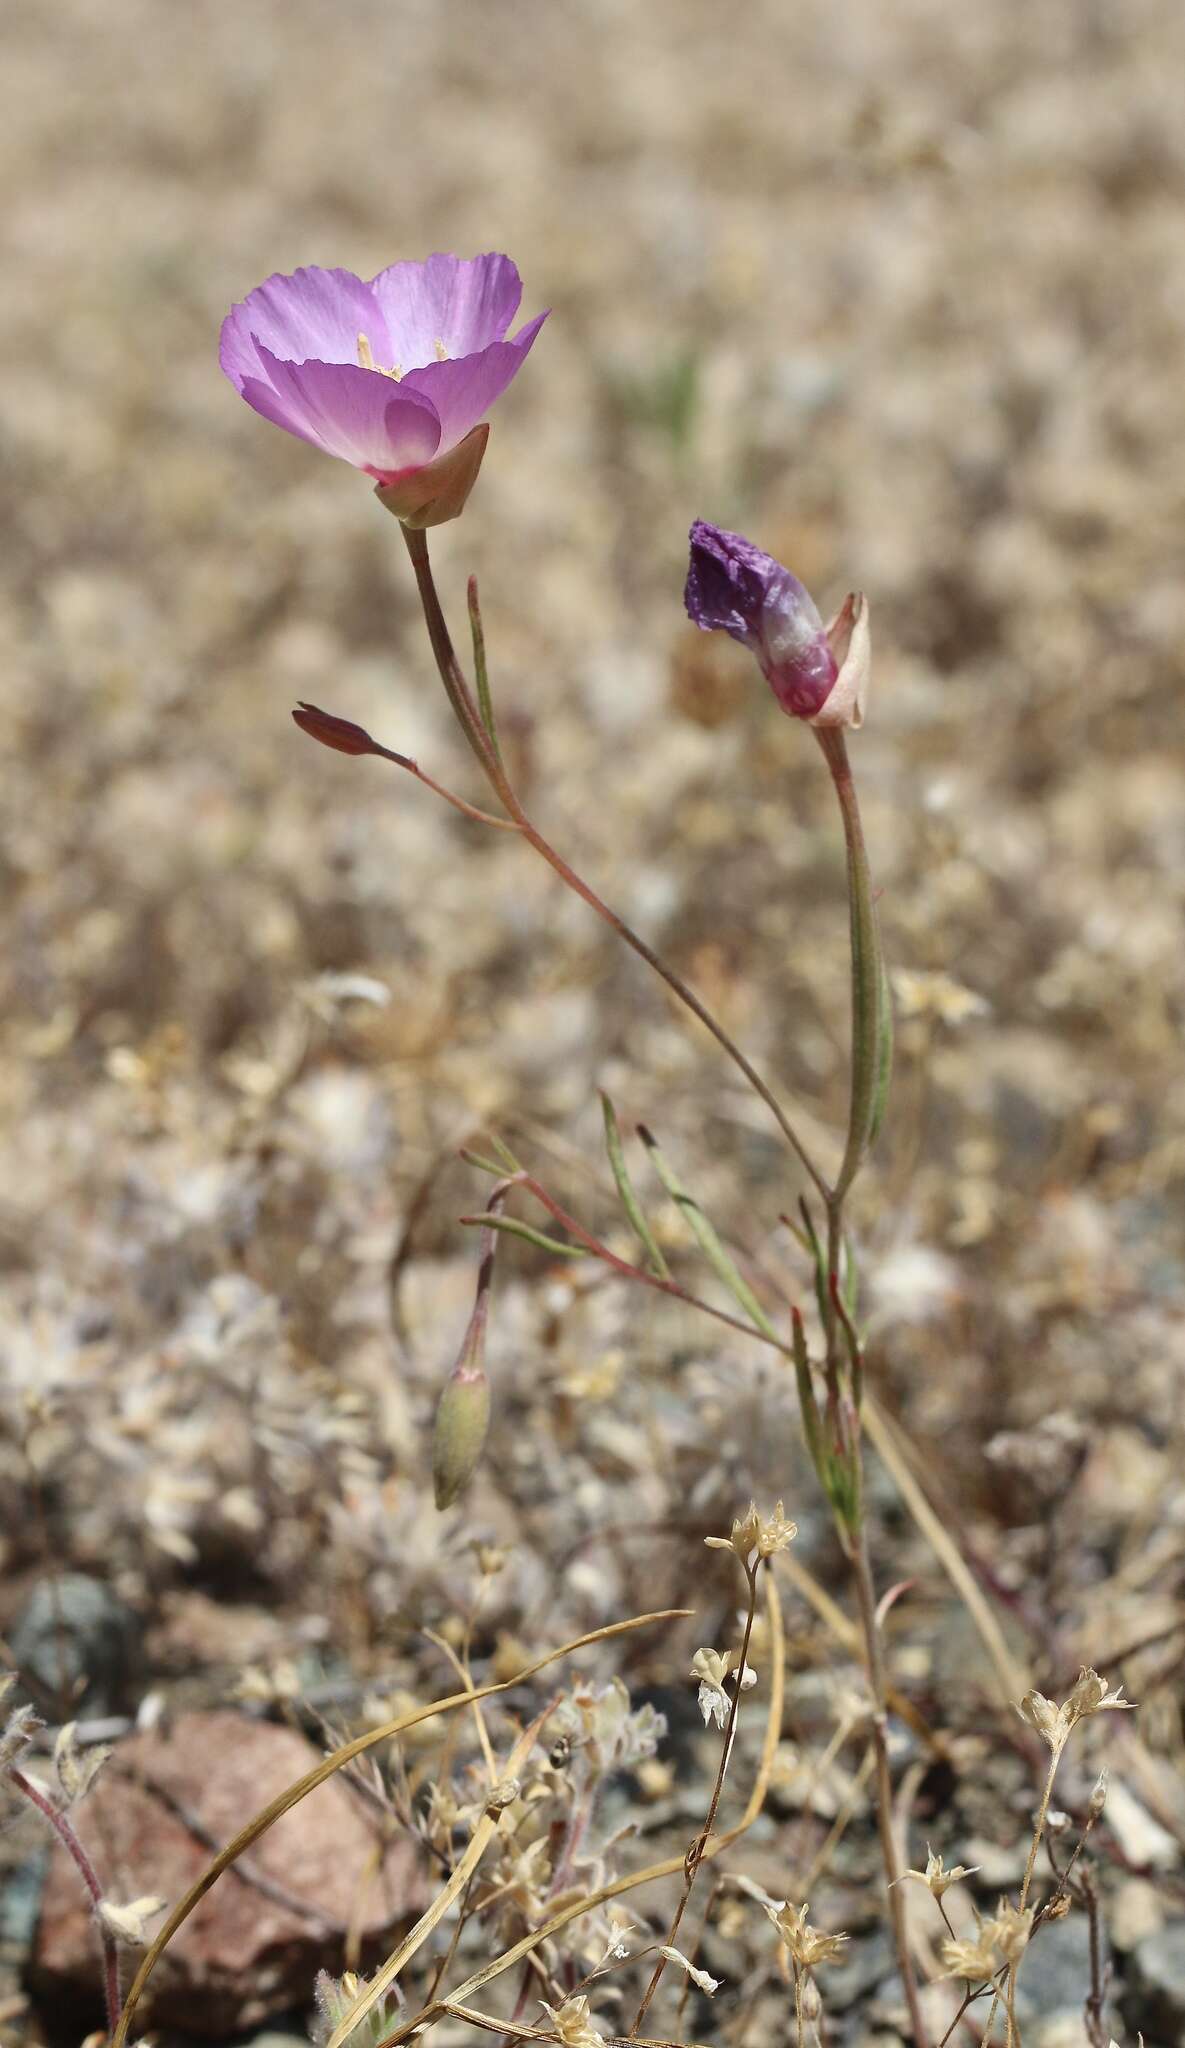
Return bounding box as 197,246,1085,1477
219,268,389,391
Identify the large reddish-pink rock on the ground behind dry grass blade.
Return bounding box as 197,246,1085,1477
29,1712,426,2038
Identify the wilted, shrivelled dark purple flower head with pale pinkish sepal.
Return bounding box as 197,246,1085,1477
684,518,868,725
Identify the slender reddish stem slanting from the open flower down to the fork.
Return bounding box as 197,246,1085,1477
403,526,829,1200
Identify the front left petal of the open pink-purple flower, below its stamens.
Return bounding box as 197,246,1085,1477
242,346,440,475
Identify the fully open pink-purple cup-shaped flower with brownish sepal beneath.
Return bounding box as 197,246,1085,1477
219,256,546,526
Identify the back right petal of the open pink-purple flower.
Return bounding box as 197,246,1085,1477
370,254,522,371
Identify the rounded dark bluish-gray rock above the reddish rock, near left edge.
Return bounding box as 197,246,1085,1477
8,1571,139,1720
